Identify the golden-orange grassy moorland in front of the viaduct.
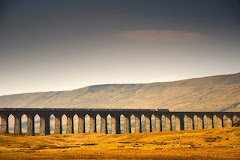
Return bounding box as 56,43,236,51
0,127,240,160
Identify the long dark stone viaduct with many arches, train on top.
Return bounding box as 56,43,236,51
0,108,240,136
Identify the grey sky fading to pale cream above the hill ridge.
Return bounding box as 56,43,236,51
0,0,240,95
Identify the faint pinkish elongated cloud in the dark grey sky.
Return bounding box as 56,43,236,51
118,30,210,42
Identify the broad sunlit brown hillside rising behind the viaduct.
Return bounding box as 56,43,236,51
0,73,240,111
